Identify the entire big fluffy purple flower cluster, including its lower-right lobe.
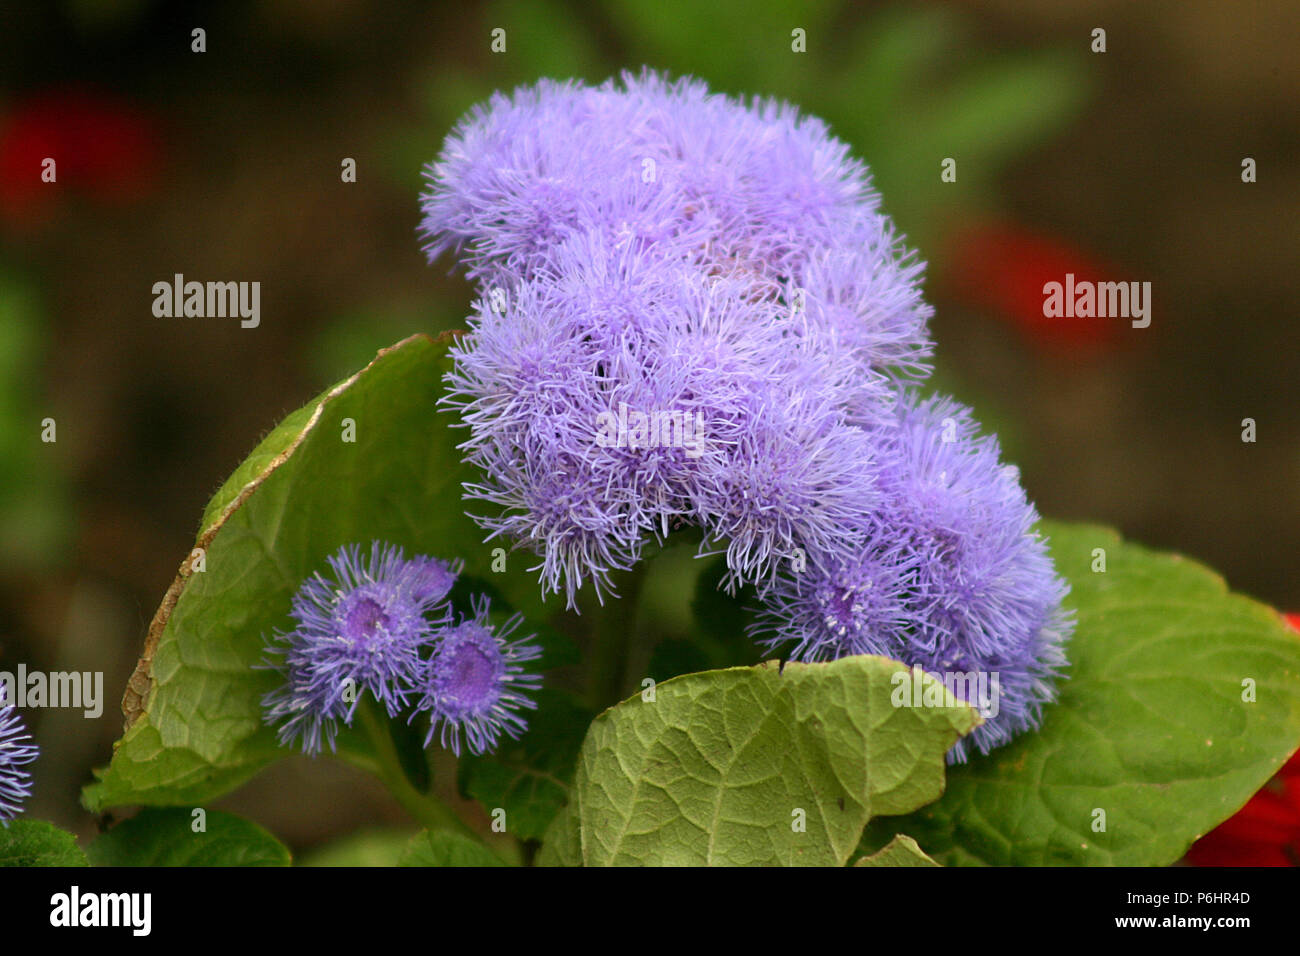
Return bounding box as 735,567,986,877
423,72,1070,758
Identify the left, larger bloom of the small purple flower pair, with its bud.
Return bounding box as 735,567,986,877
263,541,459,753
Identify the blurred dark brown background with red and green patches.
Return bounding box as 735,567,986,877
0,0,1300,857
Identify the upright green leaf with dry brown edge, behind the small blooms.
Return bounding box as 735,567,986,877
83,336,540,810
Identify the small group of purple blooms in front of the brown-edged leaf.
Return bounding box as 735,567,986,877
263,541,541,754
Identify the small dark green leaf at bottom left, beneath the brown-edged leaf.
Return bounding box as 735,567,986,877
86,808,289,866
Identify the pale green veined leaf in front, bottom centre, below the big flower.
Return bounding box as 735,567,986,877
538,657,979,866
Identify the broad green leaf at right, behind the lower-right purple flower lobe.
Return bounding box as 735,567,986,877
867,523,1300,866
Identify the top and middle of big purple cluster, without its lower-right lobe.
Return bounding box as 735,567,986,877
423,72,930,605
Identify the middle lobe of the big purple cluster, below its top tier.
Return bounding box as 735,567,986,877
446,237,888,604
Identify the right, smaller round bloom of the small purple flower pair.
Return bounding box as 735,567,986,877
416,597,542,757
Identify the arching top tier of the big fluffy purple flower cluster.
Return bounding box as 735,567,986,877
421,70,931,371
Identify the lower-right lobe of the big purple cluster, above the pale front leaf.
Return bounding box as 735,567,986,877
755,395,1073,762
